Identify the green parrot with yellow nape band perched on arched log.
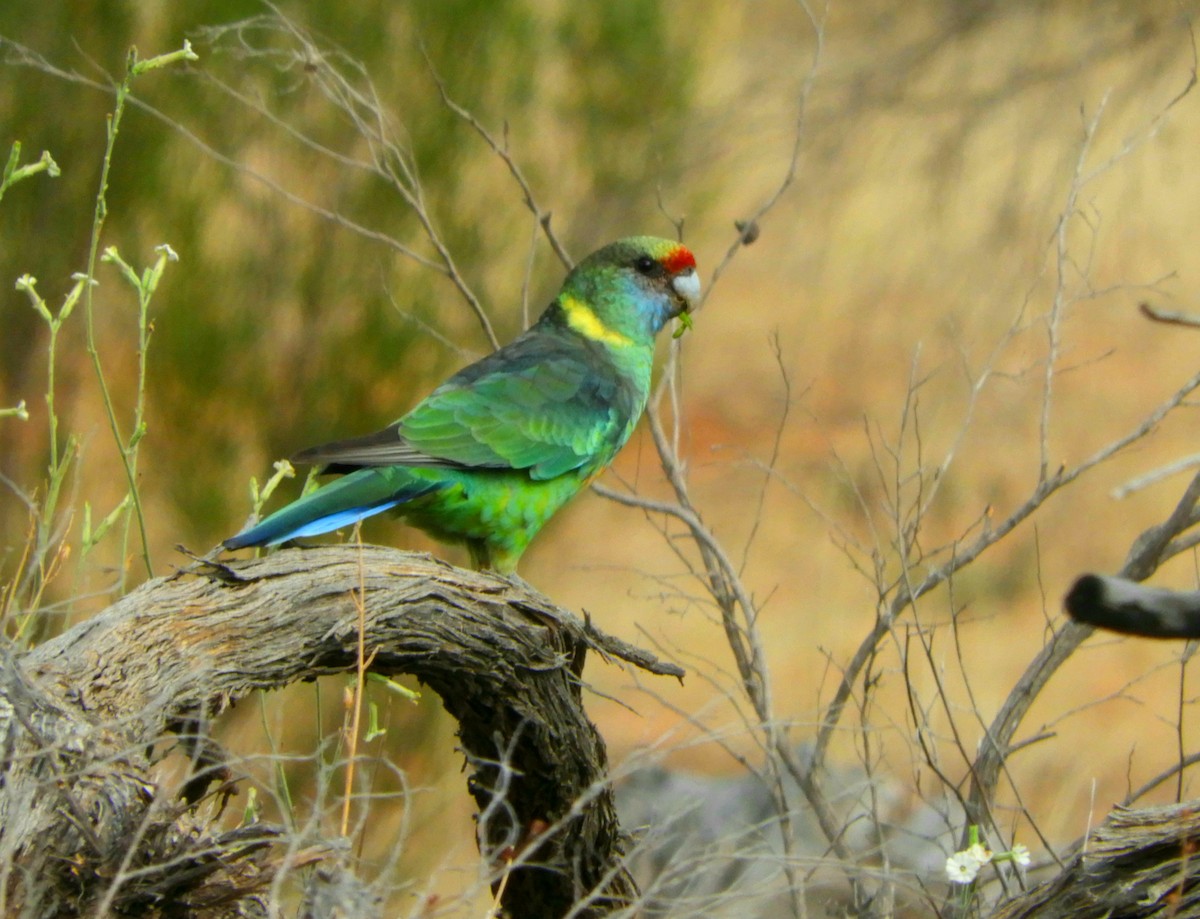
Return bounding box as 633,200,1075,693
222,236,701,575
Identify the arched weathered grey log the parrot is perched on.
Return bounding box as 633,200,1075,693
0,546,682,919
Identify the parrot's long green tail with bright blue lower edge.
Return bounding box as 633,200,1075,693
223,467,442,549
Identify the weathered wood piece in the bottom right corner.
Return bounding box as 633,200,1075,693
991,803,1200,919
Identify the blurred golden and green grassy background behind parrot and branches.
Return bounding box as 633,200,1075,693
0,0,1200,908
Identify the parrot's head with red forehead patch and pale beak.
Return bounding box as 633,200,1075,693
560,236,700,344
